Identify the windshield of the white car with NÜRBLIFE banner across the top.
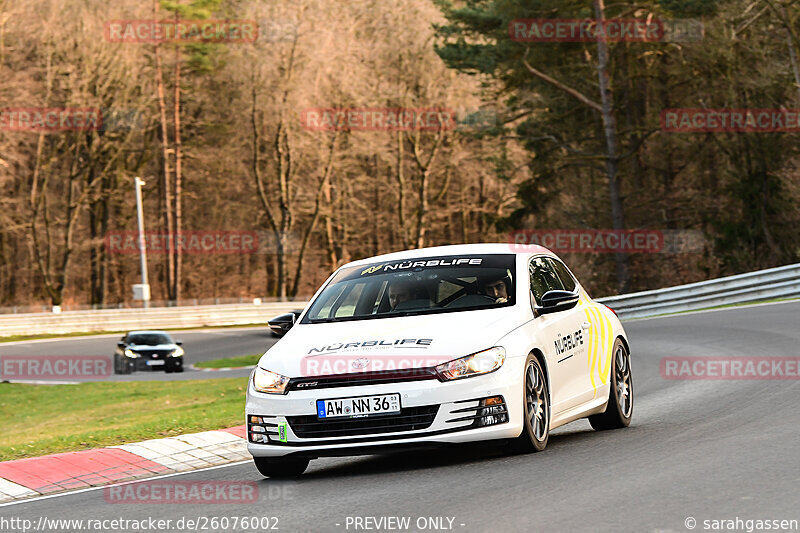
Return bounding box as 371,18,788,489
303,254,515,324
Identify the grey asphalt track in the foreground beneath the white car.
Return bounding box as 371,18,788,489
0,302,800,532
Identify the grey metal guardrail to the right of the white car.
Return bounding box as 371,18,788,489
598,264,800,319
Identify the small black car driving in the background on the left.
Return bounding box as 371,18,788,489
114,331,183,374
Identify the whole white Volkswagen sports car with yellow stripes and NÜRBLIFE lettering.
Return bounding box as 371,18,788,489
246,244,633,477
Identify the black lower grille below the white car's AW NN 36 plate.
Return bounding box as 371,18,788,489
286,405,439,439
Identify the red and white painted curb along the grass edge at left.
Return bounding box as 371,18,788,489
0,426,250,503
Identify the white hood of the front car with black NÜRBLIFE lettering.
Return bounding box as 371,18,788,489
258,306,519,377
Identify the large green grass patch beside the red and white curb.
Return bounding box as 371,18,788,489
0,378,247,461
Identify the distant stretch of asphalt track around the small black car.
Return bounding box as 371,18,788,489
0,326,278,381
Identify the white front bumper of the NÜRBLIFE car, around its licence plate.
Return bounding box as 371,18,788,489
245,358,524,457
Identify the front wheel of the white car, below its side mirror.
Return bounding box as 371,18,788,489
511,354,550,453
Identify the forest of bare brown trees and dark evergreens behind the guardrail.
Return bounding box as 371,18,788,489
0,0,800,307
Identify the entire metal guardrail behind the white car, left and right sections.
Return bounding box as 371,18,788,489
0,264,800,337
